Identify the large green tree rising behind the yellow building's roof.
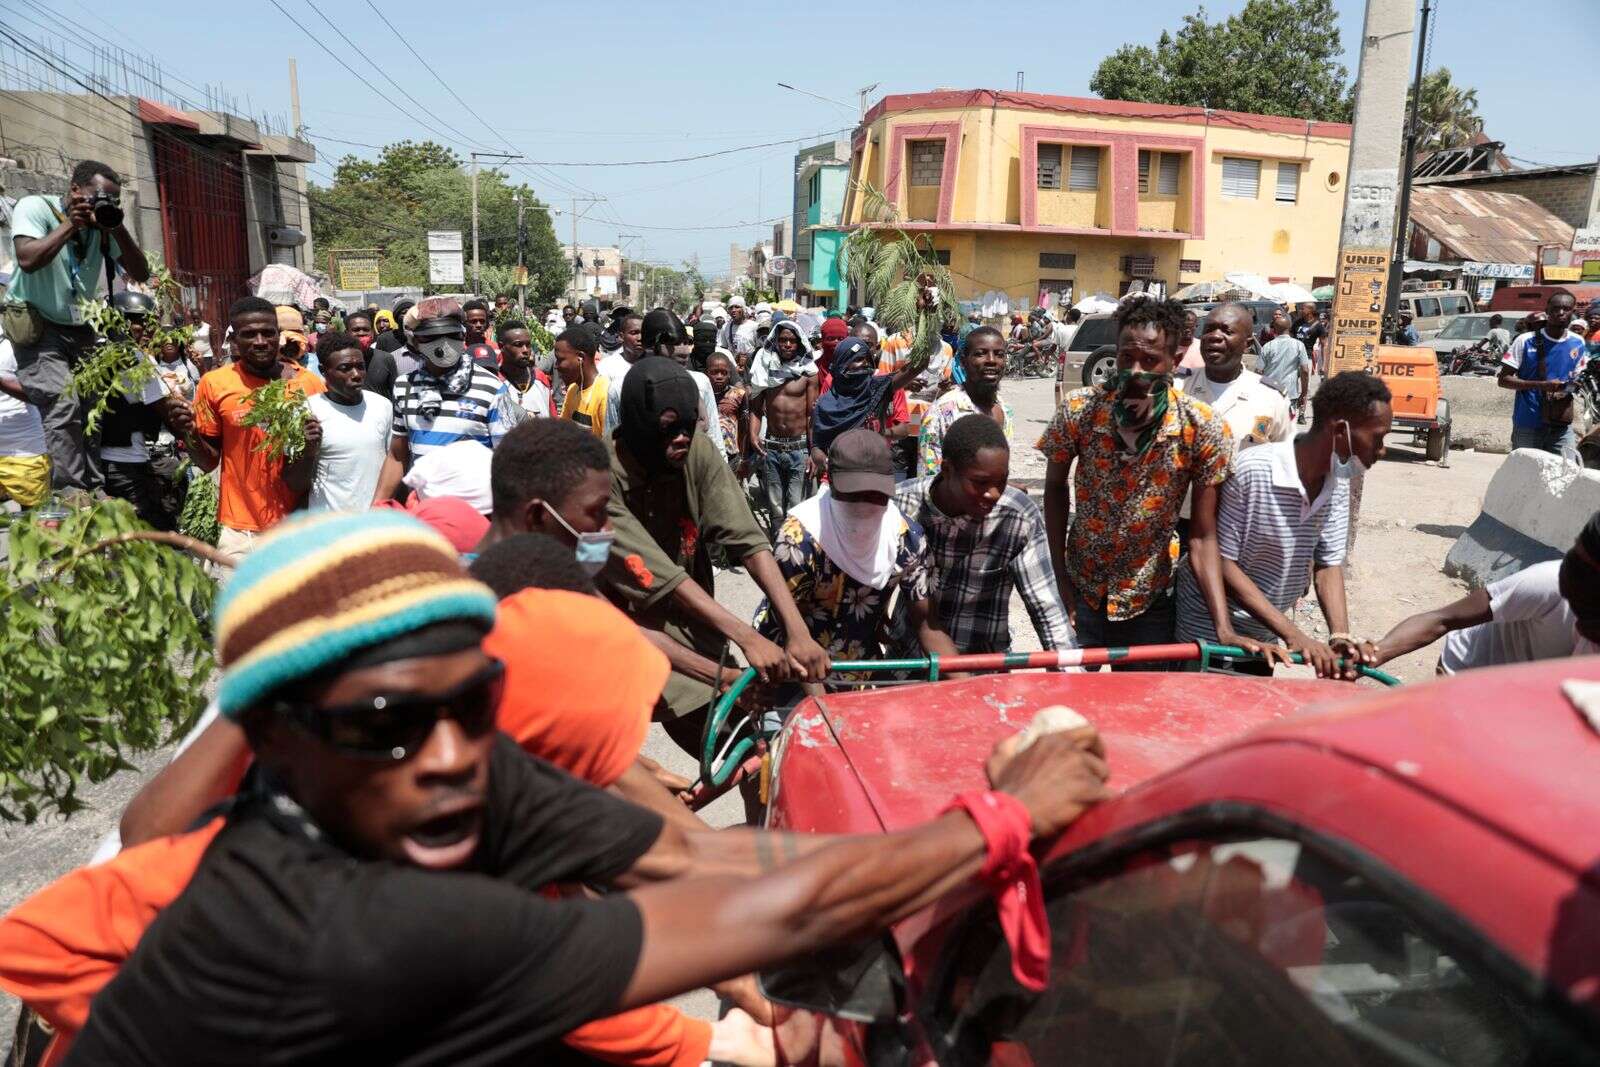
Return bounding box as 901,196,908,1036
1090,0,1354,122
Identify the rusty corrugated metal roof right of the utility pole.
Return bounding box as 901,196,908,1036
1411,186,1573,262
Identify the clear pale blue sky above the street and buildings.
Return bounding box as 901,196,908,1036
28,0,1600,275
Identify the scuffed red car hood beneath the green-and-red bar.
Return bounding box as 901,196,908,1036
776,672,1357,833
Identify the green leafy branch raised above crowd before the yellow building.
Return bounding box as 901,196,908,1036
838,182,962,366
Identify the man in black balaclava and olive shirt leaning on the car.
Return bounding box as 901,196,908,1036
600,355,829,753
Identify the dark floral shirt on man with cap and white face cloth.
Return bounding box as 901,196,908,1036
755,515,928,659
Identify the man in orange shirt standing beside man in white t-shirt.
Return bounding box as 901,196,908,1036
187,287,326,560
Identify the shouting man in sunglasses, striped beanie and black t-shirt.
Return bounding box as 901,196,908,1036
18,512,1106,1064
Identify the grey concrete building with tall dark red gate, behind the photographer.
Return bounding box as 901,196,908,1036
0,90,317,323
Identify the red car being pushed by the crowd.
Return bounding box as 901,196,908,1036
762,657,1600,1067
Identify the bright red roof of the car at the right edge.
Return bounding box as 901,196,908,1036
1227,656,1600,872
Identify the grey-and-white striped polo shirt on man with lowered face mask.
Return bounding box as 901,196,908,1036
1178,442,1350,641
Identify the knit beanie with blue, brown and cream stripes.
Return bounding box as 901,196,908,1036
216,510,494,717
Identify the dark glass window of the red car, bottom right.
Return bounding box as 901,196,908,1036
923,837,1597,1067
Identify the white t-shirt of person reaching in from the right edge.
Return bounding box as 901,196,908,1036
1438,560,1600,673
